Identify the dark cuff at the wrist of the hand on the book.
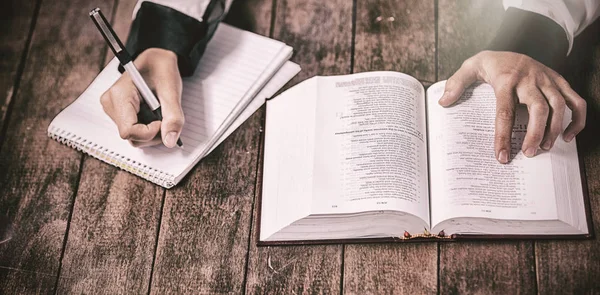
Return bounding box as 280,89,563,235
487,7,569,70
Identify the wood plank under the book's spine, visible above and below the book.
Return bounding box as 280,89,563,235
344,0,438,294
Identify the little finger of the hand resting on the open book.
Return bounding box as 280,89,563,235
553,72,587,142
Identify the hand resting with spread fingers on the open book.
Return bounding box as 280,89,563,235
439,51,586,164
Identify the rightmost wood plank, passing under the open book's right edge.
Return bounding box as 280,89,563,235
535,22,600,294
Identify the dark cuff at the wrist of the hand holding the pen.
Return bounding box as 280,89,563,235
126,0,223,77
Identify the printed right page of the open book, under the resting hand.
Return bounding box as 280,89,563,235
427,82,562,225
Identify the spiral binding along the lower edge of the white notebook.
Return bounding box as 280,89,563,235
48,126,175,188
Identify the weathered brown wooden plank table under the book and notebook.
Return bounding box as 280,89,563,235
0,0,600,294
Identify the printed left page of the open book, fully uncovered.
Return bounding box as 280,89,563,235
312,72,429,223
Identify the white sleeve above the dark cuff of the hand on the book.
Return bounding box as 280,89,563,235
504,0,600,53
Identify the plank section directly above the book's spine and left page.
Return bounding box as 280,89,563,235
354,0,435,81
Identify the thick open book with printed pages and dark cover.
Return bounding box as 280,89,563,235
259,72,591,244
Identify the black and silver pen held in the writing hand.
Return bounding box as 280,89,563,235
90,8,183,147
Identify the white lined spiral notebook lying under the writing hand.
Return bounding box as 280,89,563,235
48,24,300,188
